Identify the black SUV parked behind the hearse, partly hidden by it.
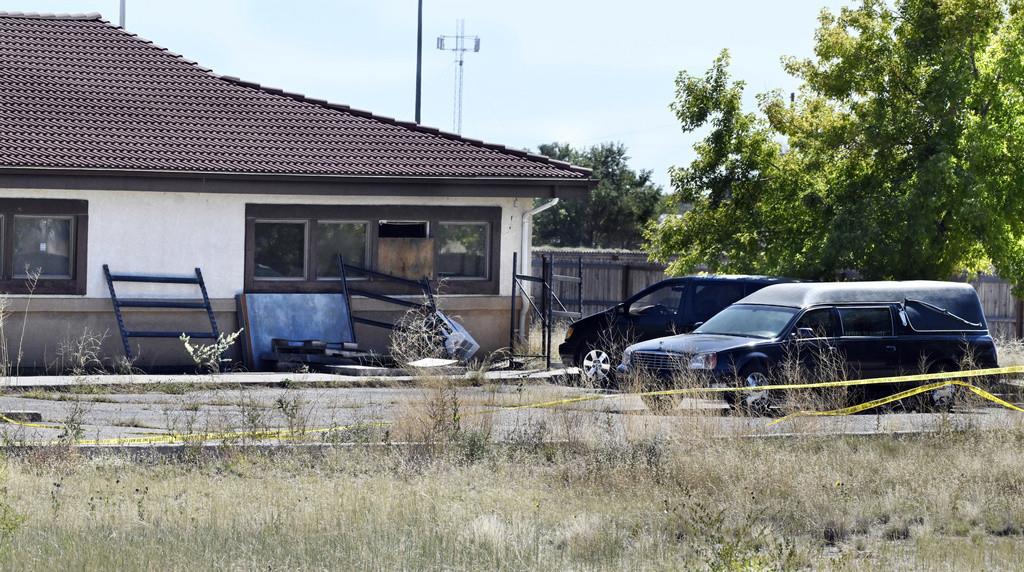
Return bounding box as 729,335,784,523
558,275,787,384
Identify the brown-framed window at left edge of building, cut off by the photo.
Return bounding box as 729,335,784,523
0,199,89,295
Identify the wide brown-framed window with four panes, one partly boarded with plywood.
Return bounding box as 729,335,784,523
245,204,502,295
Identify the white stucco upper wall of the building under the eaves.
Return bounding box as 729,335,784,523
0,188,531,298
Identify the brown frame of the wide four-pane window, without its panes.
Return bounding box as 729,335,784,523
244,203,502,295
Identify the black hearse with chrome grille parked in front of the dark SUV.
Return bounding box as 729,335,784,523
618,280,996,410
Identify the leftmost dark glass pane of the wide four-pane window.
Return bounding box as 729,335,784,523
254,222,306,280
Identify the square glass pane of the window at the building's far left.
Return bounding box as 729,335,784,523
14,216,72,278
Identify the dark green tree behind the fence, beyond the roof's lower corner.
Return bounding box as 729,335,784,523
534,143,664,248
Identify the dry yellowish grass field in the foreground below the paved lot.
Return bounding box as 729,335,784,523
0,429,1024,570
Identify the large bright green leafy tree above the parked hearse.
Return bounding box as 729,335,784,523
647,0,1024,283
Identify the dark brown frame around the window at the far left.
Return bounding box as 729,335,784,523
0,199,89,296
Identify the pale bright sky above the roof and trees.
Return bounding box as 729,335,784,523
8,0,851,188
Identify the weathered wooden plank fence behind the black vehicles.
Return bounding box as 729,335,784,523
530,248,1024,338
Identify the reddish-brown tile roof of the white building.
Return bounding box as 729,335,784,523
0,12,590,181
